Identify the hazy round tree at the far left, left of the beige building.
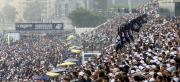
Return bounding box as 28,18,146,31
3,5,18,22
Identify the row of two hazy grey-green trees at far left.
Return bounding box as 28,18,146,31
0,0,43,22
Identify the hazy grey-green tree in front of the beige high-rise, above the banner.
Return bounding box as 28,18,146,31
23,0,42,20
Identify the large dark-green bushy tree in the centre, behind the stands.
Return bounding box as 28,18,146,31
68,8,107,27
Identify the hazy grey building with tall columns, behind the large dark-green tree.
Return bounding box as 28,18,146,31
54,0,85,19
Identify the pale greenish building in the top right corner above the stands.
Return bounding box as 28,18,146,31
158,0,180,17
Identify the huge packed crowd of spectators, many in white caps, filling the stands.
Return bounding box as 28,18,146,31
0,0,180,82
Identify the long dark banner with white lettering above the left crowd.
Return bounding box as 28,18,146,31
15,23,64,31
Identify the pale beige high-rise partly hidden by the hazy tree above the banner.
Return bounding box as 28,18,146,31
14,0,55,21
